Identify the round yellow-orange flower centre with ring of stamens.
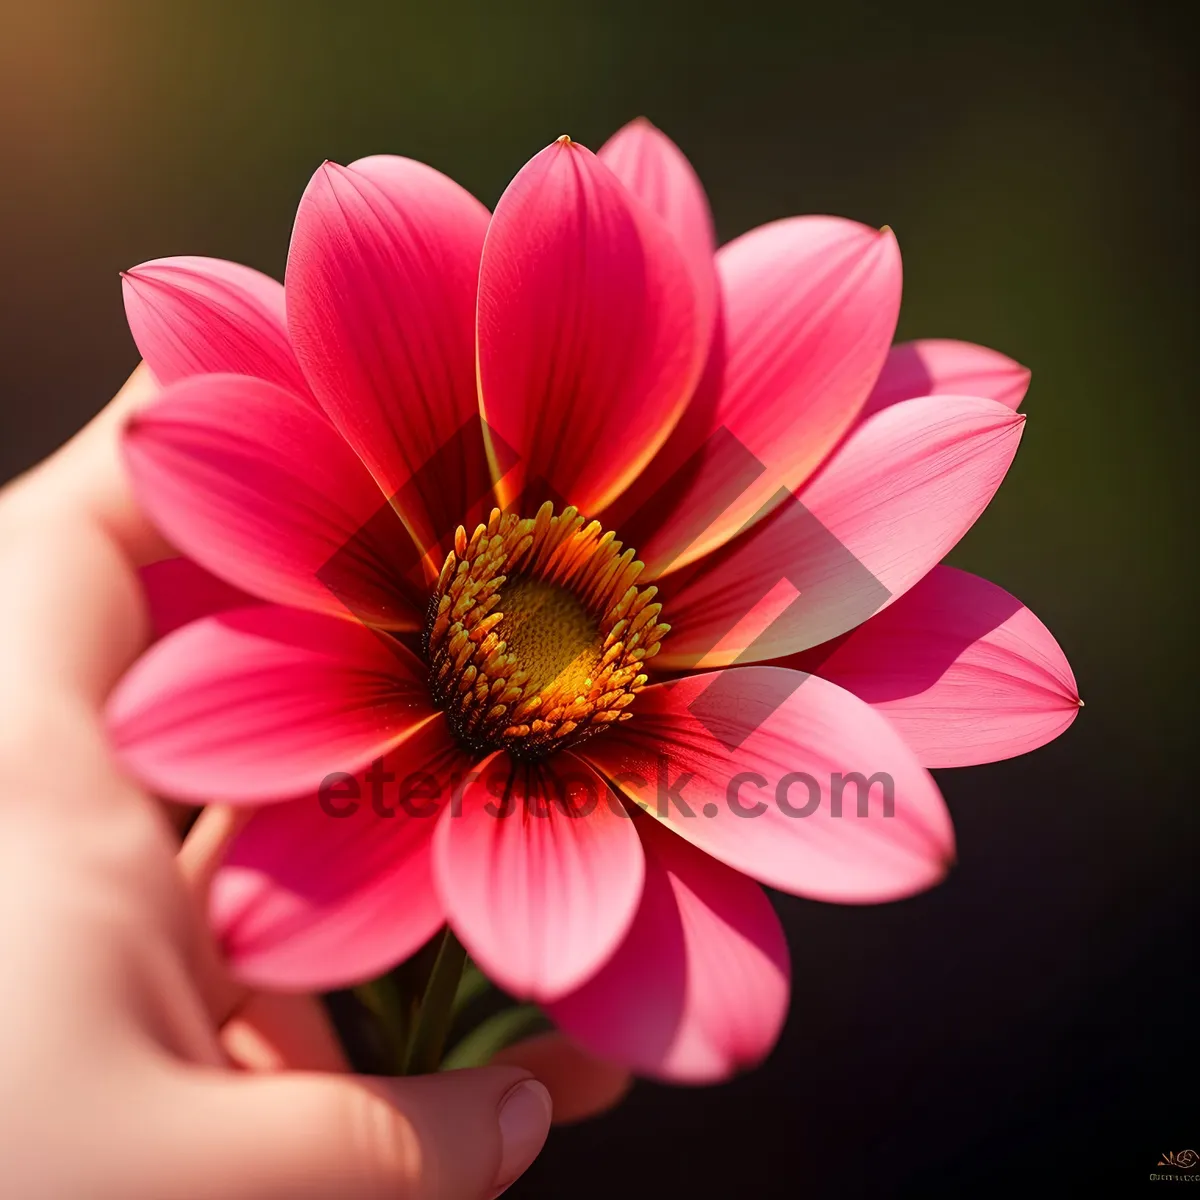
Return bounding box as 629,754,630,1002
425,502,671,757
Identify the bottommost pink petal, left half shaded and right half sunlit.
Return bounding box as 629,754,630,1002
547,818,790,1084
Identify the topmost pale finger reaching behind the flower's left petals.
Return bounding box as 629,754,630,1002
4,364,173,565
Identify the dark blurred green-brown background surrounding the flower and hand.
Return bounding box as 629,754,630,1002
0,0,1200,1200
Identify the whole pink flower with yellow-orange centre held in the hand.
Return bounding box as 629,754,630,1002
110,121,1079,1081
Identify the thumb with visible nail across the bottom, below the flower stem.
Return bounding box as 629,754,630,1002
160,1067,551,1200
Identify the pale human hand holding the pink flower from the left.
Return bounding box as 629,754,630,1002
0,370,628,1200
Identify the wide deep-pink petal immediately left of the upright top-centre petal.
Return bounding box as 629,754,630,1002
287,155,491,571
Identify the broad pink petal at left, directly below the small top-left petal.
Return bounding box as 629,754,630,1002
125,376,424,629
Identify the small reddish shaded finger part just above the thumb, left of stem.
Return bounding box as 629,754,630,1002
221,991,349,1072
